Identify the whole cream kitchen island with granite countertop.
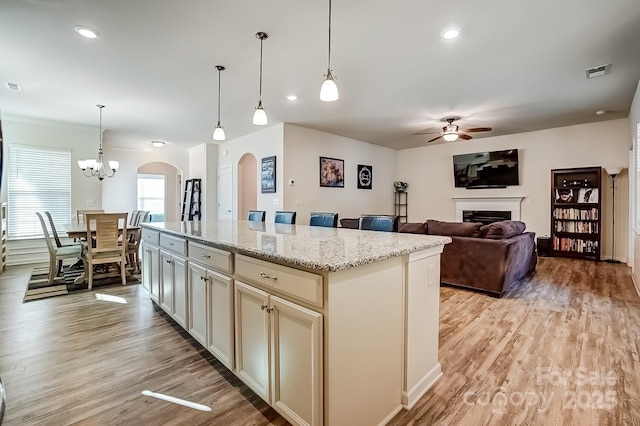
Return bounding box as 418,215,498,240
142,221,451,425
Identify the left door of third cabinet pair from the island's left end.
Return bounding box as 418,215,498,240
187,262,208,348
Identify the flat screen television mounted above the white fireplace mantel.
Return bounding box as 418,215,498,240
453,149,520,189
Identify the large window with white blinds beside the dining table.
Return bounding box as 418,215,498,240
7,144,71,238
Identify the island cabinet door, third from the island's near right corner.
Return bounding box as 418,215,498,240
207,270,234,370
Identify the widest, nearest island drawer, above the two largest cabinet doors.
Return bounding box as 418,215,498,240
236,255,322,308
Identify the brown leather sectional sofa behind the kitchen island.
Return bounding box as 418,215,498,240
398,220,538,297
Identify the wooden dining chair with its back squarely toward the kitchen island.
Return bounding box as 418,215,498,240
84,213,128,290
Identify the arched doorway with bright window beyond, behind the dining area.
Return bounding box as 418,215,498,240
136,162,182,222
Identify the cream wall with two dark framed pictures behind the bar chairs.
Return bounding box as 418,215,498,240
278,124,398,224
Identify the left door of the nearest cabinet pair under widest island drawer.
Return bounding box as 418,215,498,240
234,281,271,402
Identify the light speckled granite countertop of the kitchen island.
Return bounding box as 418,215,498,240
142,220,451,272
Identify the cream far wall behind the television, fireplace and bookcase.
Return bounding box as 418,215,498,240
398,119,629,259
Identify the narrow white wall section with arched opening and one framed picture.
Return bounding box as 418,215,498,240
218,124,284,222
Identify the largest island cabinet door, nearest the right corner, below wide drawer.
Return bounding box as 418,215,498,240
269,296,323,425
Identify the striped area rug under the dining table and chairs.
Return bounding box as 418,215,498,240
23,266,140,302
